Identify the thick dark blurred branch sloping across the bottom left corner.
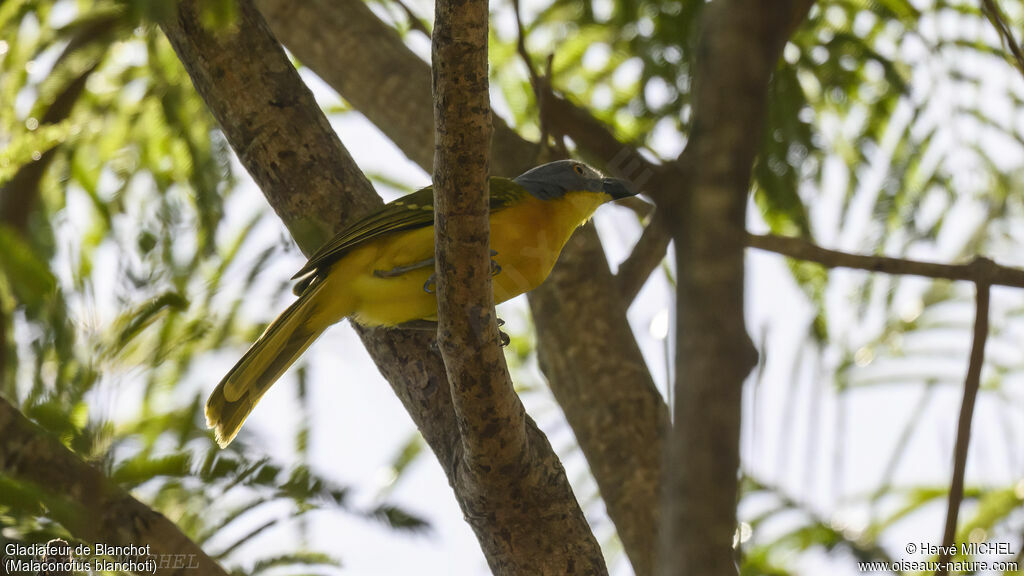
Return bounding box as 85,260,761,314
0,398,227,576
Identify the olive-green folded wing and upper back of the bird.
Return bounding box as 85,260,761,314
292,177,529,279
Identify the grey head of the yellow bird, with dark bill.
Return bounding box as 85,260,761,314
515,160,636,200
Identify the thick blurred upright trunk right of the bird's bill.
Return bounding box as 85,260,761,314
659,0,811,576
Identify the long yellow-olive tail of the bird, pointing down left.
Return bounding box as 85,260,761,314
206,282,329,448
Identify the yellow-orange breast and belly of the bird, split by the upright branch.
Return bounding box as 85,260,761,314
322,192,609,326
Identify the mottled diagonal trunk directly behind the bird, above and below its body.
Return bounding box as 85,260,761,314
161,0,603,574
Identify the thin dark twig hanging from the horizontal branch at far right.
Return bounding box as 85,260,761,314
935,272,995,576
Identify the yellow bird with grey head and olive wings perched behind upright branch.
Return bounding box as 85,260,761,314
206,160,636,448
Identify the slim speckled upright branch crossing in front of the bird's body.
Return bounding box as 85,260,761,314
431,0,526,479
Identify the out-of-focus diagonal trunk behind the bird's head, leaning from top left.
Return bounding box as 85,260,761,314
256,0,666,576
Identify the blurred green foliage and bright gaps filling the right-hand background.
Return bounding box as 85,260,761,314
492,0,1024,574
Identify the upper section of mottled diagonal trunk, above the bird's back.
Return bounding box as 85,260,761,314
161,2,382,254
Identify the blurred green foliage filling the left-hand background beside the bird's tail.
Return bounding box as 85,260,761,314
0,0,426,574
